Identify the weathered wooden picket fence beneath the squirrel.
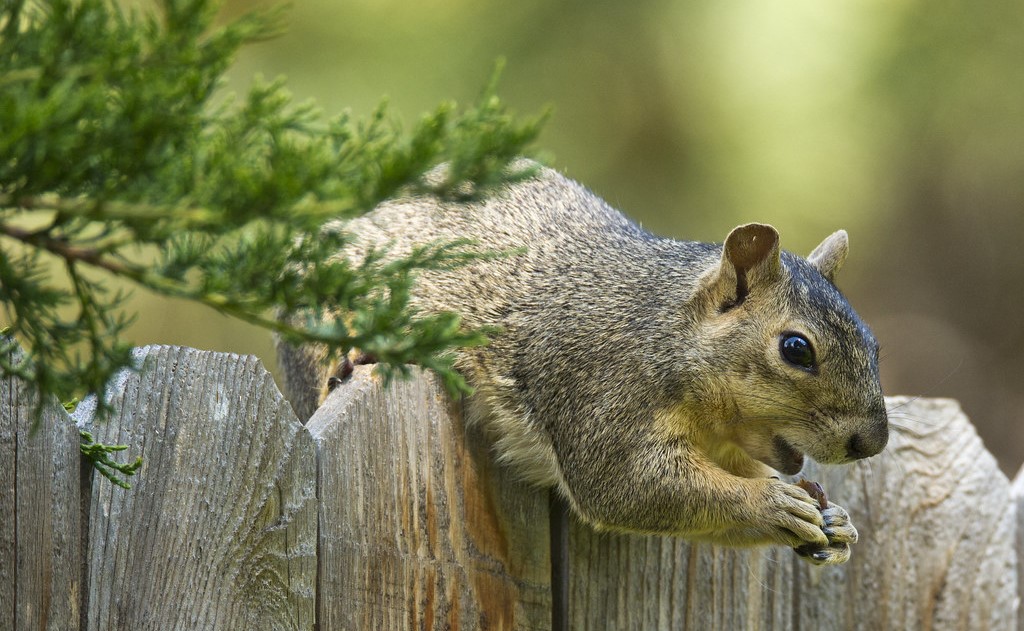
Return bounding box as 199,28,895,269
0,346,1024,630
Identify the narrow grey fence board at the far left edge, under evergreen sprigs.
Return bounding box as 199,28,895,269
0,344,81,631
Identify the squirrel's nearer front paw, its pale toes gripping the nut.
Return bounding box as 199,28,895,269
758,479,827,548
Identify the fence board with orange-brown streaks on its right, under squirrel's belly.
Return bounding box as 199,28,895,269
309,367,551,631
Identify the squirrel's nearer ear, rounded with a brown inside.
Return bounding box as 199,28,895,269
717,223,782,306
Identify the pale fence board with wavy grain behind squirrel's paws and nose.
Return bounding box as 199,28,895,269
799,397,1019,629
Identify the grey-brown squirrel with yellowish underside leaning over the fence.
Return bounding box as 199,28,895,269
280,161,889,564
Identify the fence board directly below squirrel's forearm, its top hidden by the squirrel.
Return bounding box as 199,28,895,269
568,523,796,631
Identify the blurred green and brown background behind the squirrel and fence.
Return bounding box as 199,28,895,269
121,0,1024,472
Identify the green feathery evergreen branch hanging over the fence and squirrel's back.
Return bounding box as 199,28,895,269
0,0,543,487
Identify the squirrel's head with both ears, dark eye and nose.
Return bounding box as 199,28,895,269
694,223,889,474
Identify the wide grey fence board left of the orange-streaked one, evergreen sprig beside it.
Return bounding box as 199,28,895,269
76,346,316,630
